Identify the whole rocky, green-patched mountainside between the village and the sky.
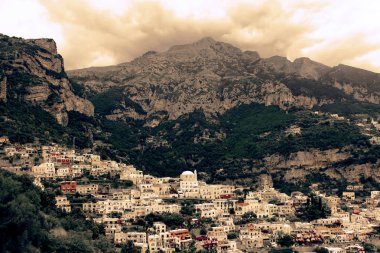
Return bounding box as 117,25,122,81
0,36,380,187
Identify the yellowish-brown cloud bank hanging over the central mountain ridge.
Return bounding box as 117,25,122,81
40,0,378,72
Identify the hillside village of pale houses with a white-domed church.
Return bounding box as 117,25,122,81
0,132,380,253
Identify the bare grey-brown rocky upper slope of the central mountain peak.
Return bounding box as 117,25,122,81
68,38,379,119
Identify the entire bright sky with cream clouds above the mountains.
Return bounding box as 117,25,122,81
0,0,380,73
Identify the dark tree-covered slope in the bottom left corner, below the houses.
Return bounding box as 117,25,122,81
0,169,115,252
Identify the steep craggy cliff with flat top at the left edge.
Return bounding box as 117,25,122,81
0,35,94,125
